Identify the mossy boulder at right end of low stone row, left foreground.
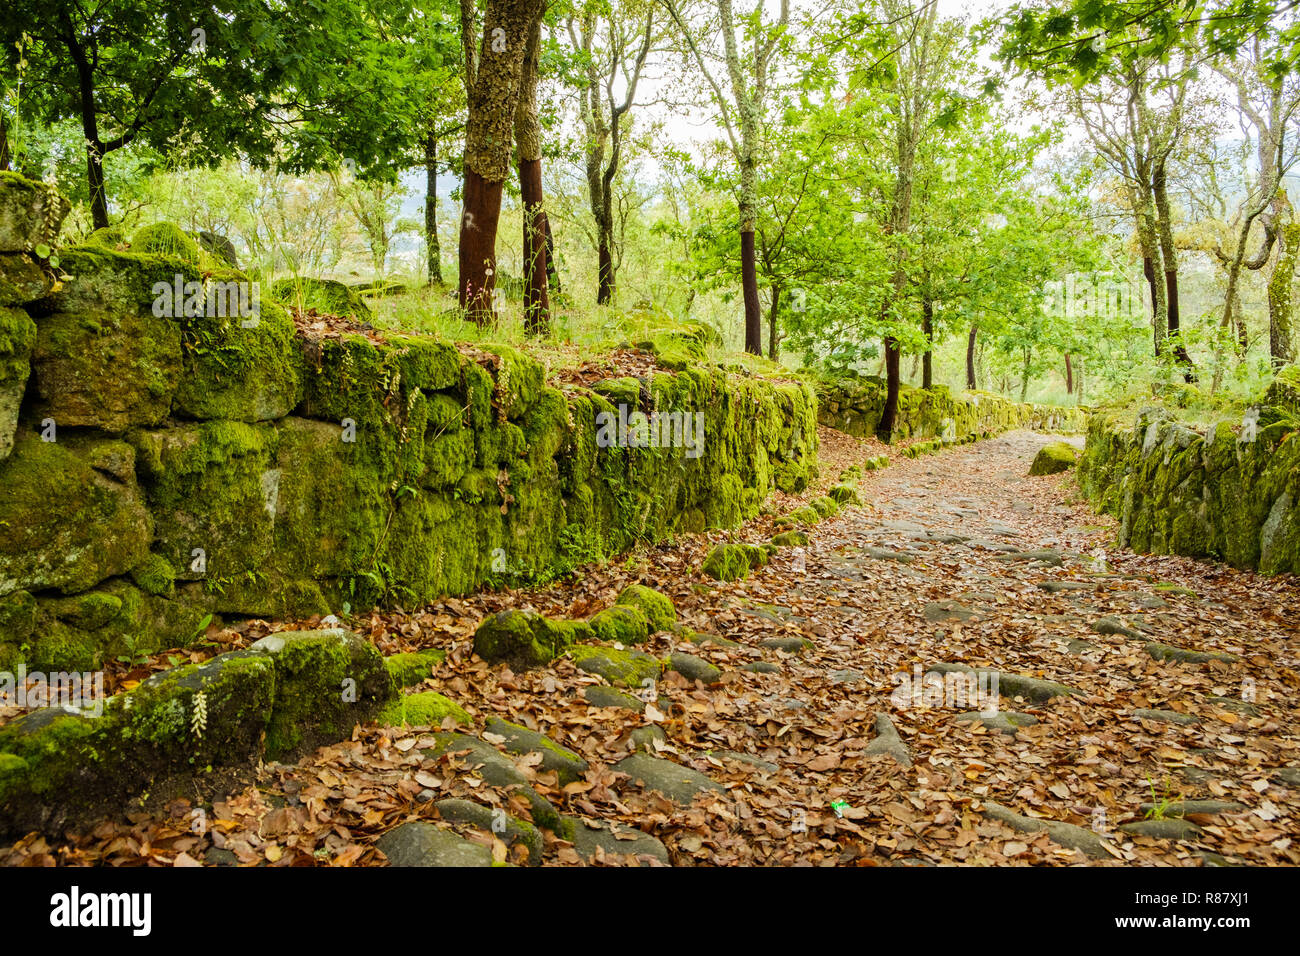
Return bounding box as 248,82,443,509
250,630,393,760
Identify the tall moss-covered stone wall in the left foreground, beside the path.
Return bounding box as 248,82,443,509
0,177,816,670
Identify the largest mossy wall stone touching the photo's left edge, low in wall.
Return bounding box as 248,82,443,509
0,432,152,596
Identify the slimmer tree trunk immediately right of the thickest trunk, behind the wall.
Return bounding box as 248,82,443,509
515,10,551,336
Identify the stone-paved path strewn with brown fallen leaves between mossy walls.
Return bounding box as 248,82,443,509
9,432,1300,866
